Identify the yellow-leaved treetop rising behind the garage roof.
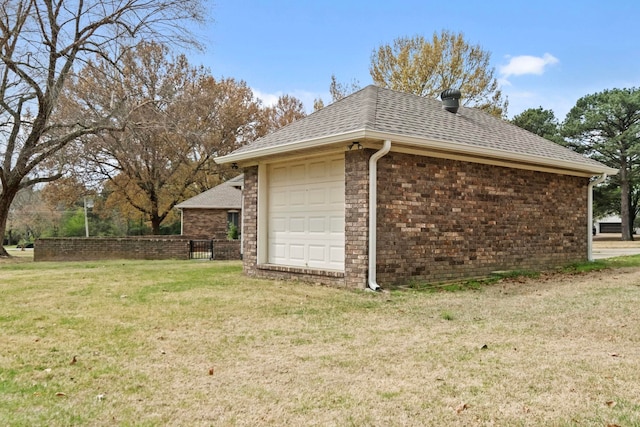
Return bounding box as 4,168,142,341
369,30,508,117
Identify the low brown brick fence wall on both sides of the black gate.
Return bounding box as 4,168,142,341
33,236,240,261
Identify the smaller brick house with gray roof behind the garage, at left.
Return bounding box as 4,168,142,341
176,175,243,240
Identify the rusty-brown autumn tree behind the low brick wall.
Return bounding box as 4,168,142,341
67,42,262,234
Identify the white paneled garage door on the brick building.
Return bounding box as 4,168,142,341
268,155,344,270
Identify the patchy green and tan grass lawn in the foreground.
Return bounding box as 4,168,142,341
0,256,640,426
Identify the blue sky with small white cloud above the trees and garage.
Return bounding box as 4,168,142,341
189,0,640,120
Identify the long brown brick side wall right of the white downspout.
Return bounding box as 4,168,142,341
377,153,588,284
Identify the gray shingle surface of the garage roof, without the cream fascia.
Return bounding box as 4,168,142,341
226,85,602,171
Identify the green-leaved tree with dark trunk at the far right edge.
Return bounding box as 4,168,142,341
562,88,640,240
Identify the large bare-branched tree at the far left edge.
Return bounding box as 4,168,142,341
0,0,205,256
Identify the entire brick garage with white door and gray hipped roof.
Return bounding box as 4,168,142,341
216,86,617,289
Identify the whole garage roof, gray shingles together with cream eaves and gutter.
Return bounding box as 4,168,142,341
216,85,617,174
